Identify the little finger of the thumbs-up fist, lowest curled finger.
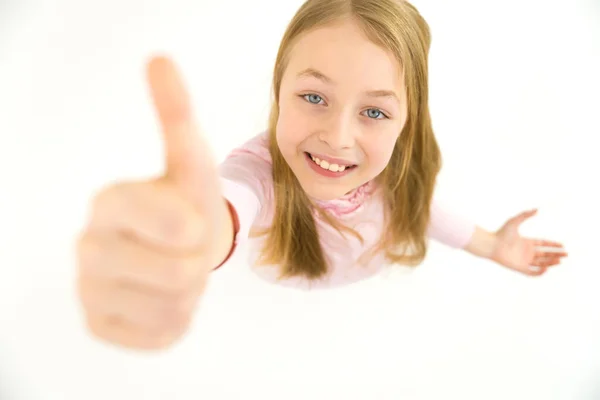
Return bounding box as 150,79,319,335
85,314,183,350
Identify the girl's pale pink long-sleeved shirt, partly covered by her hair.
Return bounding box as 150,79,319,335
219,133,475,289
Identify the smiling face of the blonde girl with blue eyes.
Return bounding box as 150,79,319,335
277,20,407,200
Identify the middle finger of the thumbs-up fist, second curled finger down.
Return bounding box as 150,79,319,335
77,233,209,294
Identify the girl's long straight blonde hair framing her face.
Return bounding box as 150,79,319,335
253,0,441,280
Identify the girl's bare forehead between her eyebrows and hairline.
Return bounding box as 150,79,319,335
286,20,403,91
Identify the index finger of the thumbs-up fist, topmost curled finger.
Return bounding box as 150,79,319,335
88,181,206,251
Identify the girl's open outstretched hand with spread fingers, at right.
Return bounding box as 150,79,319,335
492,210,567,275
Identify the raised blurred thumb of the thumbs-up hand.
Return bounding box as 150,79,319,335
147,56,222,212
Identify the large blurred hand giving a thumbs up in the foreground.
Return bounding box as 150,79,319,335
77,57,234,349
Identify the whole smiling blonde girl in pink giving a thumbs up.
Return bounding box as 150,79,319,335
79,0,566,348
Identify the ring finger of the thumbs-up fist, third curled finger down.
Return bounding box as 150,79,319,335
78,277,204,334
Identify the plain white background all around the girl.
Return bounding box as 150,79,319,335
0,0,600,400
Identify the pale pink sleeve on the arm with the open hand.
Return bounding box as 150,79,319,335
428,200,476,249
